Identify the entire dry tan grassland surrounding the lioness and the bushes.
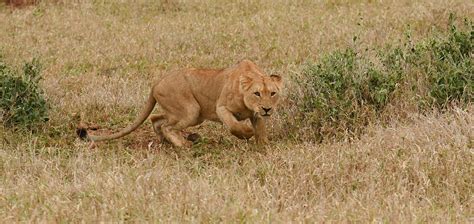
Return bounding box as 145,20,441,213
0,0,474,223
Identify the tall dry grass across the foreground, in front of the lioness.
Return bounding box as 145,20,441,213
0,107,474,222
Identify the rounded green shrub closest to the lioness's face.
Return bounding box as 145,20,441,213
293,48,400,138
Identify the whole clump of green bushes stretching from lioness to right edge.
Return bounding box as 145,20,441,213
290,16,474,140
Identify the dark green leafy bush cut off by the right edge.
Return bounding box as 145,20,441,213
420,17,474,108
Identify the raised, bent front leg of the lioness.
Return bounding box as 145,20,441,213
216,106,254,139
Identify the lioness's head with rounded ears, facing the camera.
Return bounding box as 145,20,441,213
240,74,282,117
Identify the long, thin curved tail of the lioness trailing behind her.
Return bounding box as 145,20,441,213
80,91,156,142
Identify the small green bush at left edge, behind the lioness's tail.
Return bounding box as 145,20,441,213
0,58,48,130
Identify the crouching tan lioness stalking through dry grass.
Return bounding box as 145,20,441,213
79,60,282,147
